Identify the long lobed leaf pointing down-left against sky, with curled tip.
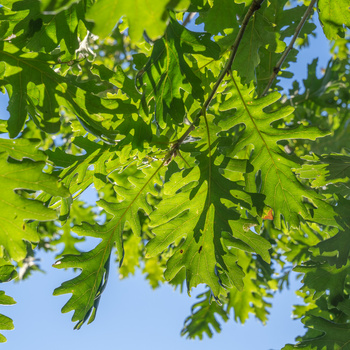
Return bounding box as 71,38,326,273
54,162,162,329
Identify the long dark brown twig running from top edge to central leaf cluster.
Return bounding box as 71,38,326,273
167,0,264,159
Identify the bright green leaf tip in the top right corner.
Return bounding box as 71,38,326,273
317,0,350,40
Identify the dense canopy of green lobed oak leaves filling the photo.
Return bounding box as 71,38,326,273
0,0,350,350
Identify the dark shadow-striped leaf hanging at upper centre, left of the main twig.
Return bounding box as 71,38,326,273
138,15,220,128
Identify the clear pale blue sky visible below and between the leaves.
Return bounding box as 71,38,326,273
0,10,329,350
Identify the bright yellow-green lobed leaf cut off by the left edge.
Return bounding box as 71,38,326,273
0,144,70,260
